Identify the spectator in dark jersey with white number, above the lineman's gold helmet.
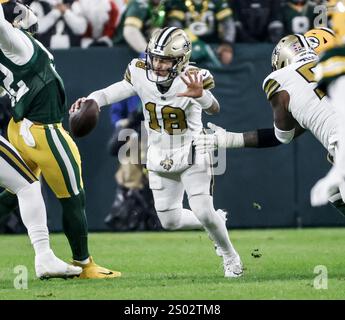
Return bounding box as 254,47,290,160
283,0,316,34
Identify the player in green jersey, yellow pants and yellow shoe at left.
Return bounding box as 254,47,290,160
0,0,120,278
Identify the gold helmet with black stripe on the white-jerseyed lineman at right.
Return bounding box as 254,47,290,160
272,34,318,71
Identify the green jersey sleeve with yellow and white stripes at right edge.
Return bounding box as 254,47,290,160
316,46,345,92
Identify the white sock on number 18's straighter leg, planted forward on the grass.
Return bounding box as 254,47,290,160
189,195,237,257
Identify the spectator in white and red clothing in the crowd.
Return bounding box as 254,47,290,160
79,0,120,48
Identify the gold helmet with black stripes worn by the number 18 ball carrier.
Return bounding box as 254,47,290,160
146,27,192,84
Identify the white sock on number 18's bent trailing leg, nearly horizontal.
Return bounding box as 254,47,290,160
157,208,203,230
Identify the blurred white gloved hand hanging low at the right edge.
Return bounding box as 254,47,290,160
310,168,344,207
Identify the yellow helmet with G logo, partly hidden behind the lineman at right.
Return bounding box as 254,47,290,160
304,28,335,54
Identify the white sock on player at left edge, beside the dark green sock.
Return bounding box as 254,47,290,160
17,181,50,255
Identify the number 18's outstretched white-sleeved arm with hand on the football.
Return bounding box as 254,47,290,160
69,80,136,114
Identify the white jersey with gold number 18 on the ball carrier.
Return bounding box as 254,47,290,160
124,59,214,171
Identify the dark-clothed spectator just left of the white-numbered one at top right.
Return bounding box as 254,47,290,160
231,0,284,43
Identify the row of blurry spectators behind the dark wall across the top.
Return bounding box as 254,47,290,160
20,0,322,66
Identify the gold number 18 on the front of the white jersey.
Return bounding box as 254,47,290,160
145,102,187,134
